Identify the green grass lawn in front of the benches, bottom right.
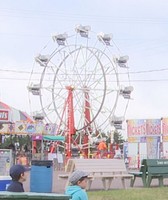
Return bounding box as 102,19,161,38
87,187,168,200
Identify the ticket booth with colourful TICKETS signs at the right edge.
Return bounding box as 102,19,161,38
124,118,168,168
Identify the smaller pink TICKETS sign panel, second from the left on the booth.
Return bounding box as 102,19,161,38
146,119,161,135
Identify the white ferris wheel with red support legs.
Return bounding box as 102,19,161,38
28,25,133,156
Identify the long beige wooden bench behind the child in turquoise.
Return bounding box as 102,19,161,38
59,159,133,190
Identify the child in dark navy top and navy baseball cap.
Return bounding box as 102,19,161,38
7,165,29,192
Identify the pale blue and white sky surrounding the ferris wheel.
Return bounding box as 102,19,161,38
0,0,168,126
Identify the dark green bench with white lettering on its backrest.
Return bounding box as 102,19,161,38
129,159,168,187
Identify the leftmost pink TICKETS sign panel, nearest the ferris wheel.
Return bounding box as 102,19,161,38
127,119,146,137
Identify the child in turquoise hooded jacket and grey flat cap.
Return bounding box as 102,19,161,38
65,170,88,200
